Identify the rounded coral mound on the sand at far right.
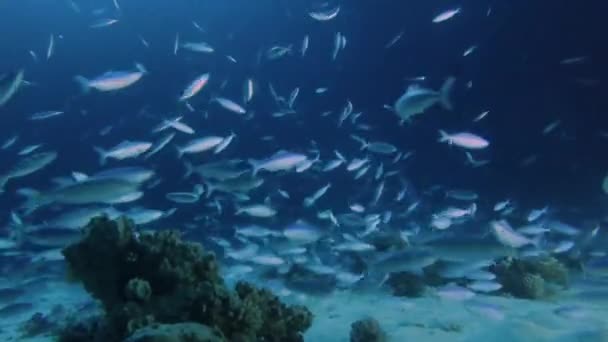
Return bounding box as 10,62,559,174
491,257,569,299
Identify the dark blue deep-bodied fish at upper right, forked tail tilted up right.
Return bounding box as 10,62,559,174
393,77,456,121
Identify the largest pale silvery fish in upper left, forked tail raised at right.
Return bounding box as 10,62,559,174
74,64,147,94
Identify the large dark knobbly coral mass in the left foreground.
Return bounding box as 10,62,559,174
63,217,313,342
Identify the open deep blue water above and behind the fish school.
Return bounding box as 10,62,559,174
0,0,608,223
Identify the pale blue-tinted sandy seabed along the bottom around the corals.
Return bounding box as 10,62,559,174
0,281,608,342
